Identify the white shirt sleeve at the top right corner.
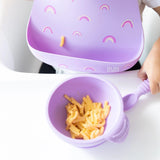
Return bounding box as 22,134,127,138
138,0,160,14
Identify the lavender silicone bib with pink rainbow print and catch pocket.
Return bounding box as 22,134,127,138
27,0,144,73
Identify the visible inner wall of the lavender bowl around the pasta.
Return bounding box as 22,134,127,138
48,76,123,137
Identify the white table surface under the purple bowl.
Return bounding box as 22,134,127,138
0,63,160,160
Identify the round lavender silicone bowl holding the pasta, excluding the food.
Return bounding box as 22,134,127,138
48,76,129,148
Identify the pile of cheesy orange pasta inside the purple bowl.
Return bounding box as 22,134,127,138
64,95,111,140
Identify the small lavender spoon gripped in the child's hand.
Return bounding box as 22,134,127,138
123,79,150,111
